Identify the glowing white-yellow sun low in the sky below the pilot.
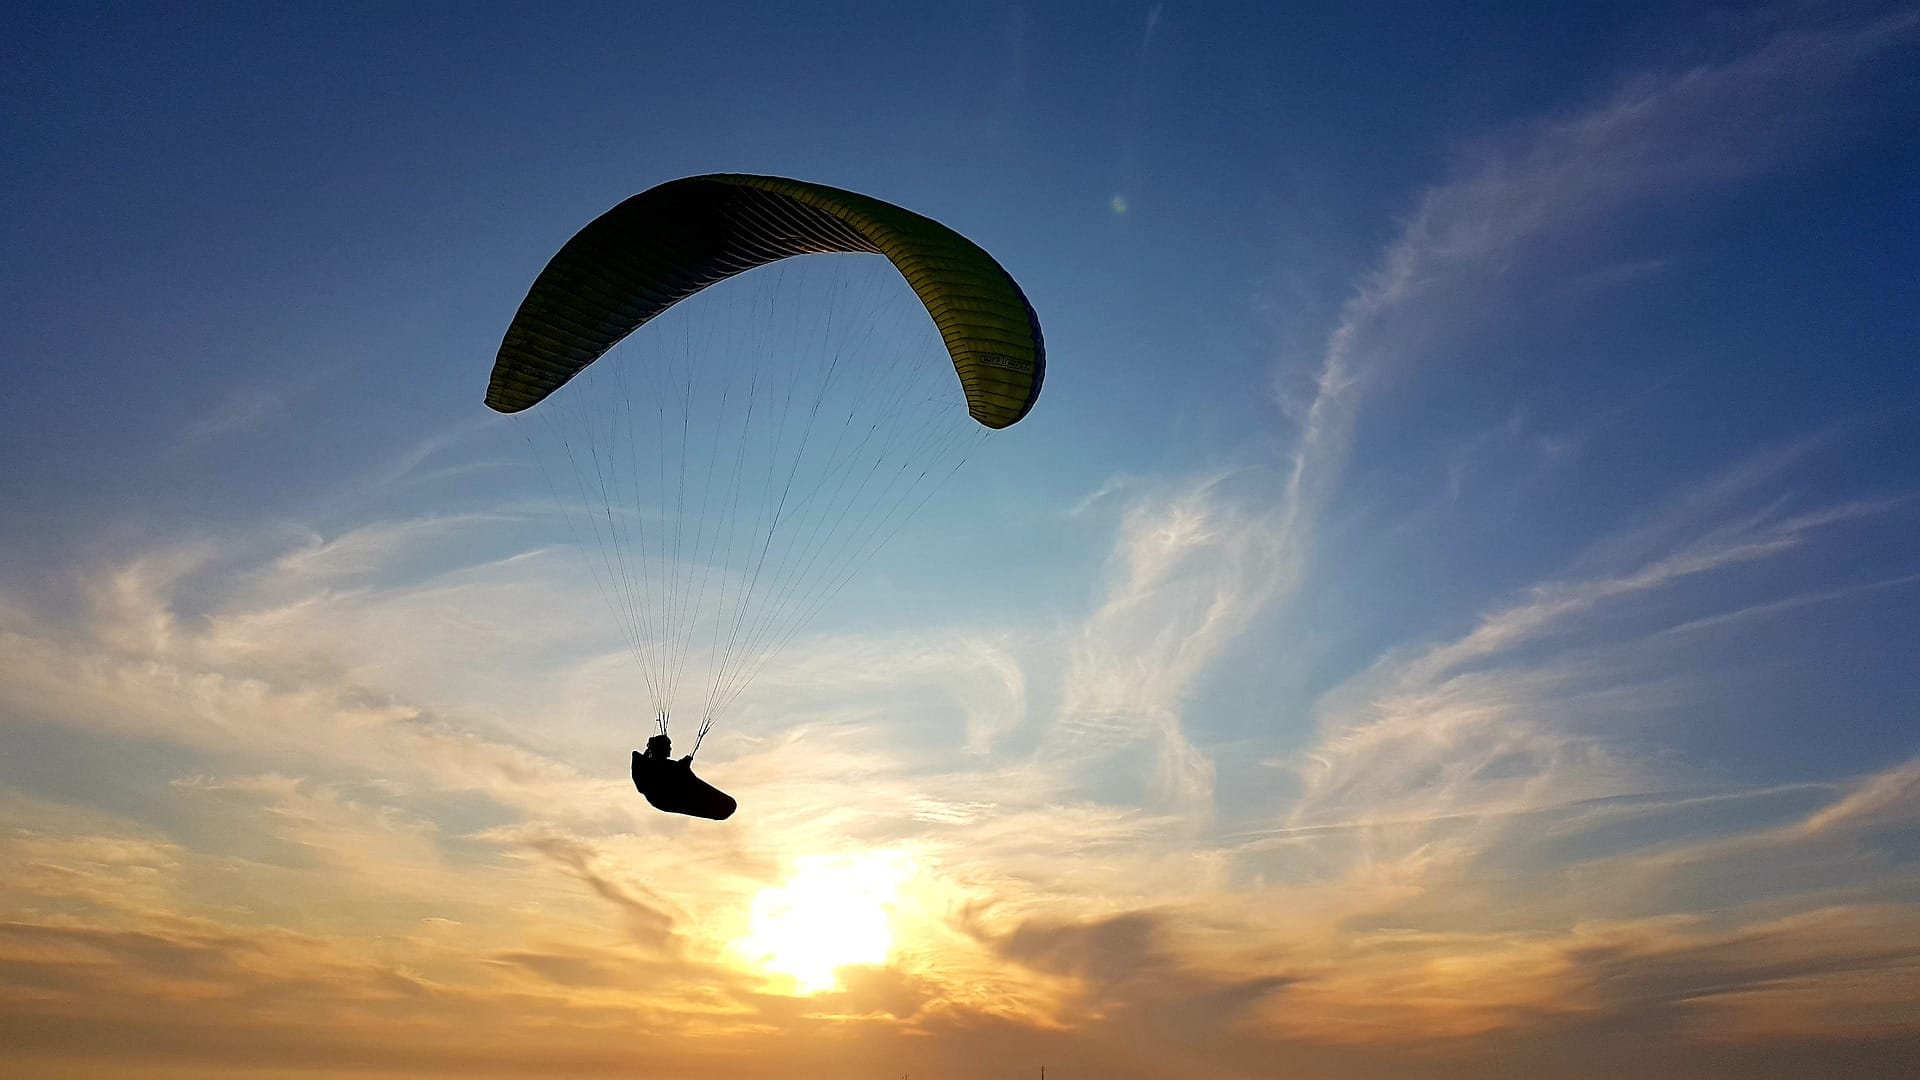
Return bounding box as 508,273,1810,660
733,851,914,994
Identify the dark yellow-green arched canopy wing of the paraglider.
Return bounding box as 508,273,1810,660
486,173,1046,429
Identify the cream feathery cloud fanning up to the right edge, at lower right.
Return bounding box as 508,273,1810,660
1275,424,1901,910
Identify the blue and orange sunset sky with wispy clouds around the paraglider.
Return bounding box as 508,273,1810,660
0,2,1920,1080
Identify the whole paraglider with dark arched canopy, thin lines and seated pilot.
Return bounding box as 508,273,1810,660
486,173,1046,819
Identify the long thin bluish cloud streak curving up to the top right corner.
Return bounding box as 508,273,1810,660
1277,13,1920,519
